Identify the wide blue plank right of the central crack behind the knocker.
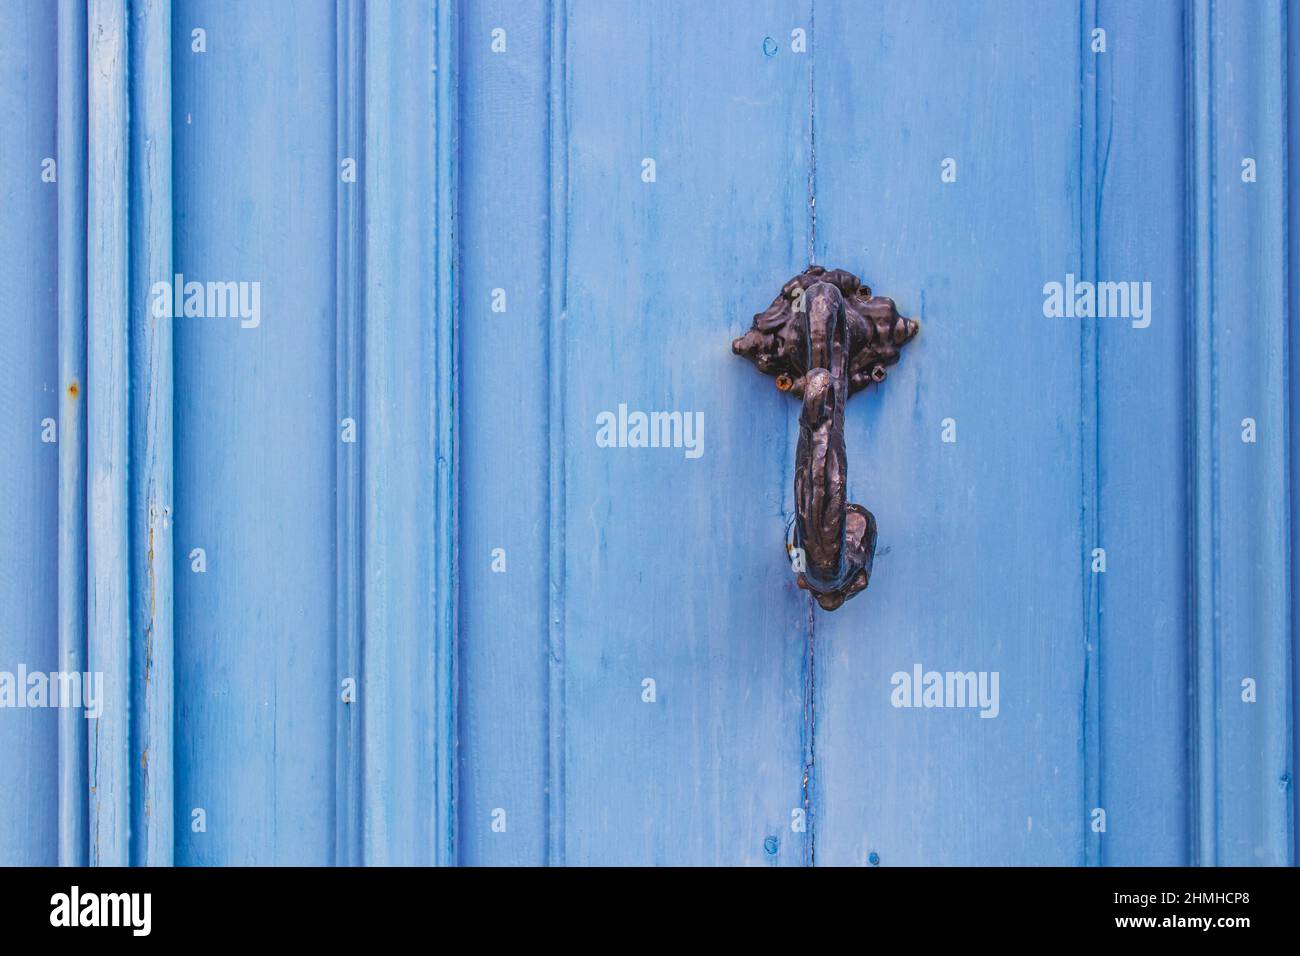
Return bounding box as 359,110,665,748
814,3,1091,866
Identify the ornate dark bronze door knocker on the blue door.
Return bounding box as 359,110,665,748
732,265,920,611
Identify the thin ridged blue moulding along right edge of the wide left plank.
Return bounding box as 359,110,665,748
334,0,365,866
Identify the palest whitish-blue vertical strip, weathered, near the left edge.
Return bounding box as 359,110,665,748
86,0,131,866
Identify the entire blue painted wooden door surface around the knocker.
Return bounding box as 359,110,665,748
0,0,1300,866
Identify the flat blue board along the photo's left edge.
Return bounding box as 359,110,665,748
0,0,59,866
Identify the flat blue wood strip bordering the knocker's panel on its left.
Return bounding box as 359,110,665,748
456,0,551,865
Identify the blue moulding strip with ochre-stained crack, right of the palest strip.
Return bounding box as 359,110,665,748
121,0,174,866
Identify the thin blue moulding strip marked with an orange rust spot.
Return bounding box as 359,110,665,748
57,0,88,866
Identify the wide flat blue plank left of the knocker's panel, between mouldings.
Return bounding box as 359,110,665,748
172,0,343,865
